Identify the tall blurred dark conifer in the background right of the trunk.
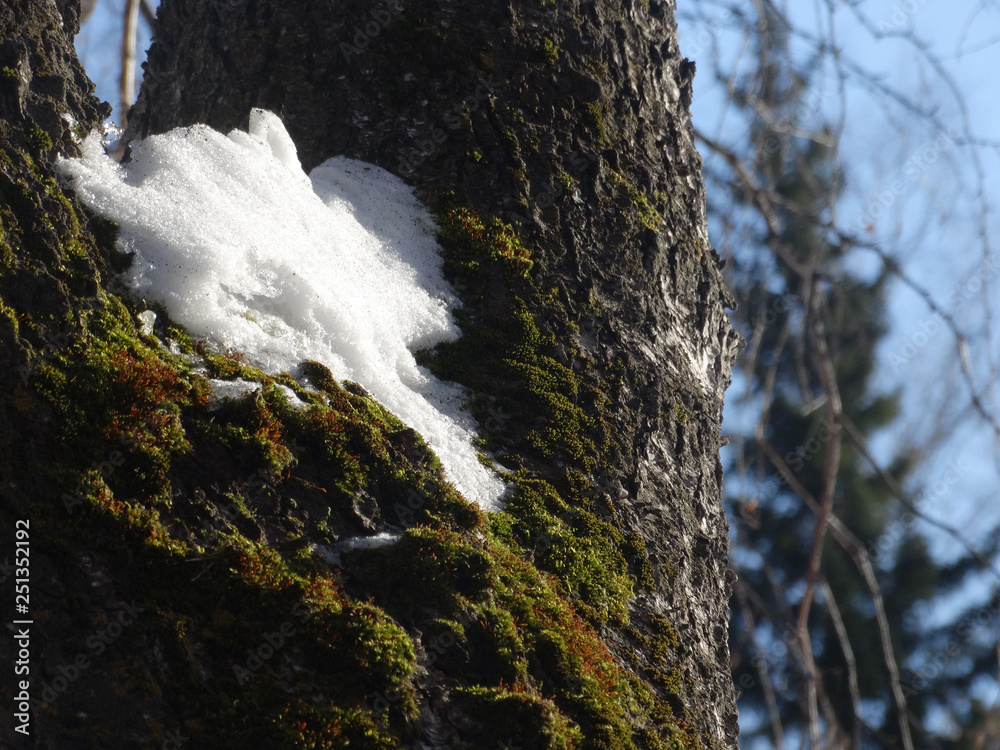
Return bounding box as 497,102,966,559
707,4,989,748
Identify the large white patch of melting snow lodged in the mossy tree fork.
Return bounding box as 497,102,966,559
59,110,503,509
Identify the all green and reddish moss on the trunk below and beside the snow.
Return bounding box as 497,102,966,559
0,70,704,750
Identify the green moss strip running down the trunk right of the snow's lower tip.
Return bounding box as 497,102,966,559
414,170,700,749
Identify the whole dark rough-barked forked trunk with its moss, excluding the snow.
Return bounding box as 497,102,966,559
0,0,739,750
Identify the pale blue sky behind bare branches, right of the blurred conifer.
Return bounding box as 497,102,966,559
678,0,1000,568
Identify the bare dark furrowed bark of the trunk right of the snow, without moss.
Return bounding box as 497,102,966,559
0,0,740,749
